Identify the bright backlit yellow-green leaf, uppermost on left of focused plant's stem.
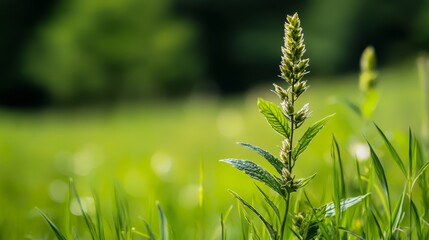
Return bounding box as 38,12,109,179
258,98,290,138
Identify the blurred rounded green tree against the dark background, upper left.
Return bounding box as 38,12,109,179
26,0,201,103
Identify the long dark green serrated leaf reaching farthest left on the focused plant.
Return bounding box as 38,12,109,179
221,159,284,196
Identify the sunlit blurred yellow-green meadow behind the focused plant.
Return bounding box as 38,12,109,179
0,59,422,239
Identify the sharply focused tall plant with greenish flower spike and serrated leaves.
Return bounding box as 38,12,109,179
222,13,367,240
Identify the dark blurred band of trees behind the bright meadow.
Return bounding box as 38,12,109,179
0,0,429,106
